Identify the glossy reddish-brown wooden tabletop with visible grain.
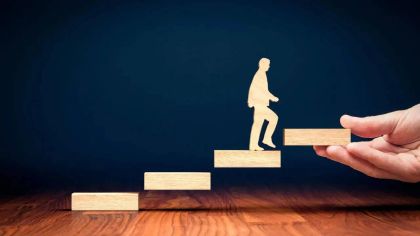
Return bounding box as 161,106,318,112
0,185,420,235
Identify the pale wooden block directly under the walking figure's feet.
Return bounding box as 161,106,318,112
214,150,281,168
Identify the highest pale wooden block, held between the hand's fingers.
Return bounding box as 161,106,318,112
283,129,351,146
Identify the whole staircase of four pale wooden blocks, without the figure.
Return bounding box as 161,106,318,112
71,129,351,211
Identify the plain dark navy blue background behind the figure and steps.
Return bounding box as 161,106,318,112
0,0,420,191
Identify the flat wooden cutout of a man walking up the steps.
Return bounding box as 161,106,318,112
248,58,279,151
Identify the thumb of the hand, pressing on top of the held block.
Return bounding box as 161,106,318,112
340,111,401,138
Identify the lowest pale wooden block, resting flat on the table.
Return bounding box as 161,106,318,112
71,193,139,211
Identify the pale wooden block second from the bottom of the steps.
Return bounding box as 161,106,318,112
144,172,211,190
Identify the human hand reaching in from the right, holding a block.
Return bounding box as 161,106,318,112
314,104,420,183
